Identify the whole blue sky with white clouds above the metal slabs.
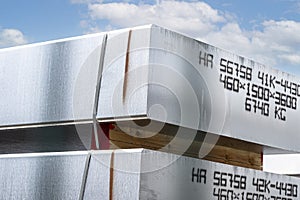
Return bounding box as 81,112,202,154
0,0,300,75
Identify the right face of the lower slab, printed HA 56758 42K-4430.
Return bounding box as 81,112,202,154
139,150,300,200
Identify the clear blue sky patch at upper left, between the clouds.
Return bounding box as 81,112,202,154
0,0,83,42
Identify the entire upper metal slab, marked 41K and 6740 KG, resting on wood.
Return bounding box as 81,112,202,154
0,25,300,151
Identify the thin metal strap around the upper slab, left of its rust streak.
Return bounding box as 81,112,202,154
93,34,107,149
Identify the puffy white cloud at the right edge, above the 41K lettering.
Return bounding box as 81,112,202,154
204,20,300,68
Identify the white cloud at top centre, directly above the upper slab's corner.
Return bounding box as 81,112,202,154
89,1,225,36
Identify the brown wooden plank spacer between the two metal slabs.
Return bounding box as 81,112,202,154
109,122,262,170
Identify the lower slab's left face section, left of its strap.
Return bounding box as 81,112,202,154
0,152,87,200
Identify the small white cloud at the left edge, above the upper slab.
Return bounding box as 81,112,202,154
0,29,28,47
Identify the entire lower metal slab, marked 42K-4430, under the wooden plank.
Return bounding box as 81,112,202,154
0,149,300,200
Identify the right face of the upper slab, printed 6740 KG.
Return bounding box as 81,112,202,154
147,27,300,151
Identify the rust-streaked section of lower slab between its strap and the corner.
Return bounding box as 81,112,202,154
84,149,143,200
